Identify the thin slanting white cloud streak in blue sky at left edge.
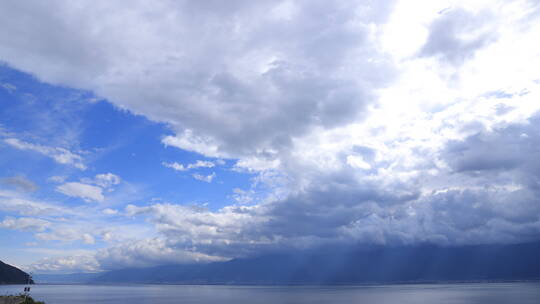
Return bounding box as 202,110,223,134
4,138,86,170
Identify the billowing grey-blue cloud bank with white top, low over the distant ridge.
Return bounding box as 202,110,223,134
115,86,540,264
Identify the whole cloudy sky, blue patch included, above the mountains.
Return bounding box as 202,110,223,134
0,0,540,273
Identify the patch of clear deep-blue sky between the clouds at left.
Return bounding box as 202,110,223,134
0,65,252,214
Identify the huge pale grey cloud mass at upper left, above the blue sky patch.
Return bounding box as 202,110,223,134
0,0,391,160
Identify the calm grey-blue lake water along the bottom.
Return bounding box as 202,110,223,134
0,282,540,304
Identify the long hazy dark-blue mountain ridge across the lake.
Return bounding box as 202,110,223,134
89,243,540,284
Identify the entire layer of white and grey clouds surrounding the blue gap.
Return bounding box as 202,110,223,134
0,0,540,270
